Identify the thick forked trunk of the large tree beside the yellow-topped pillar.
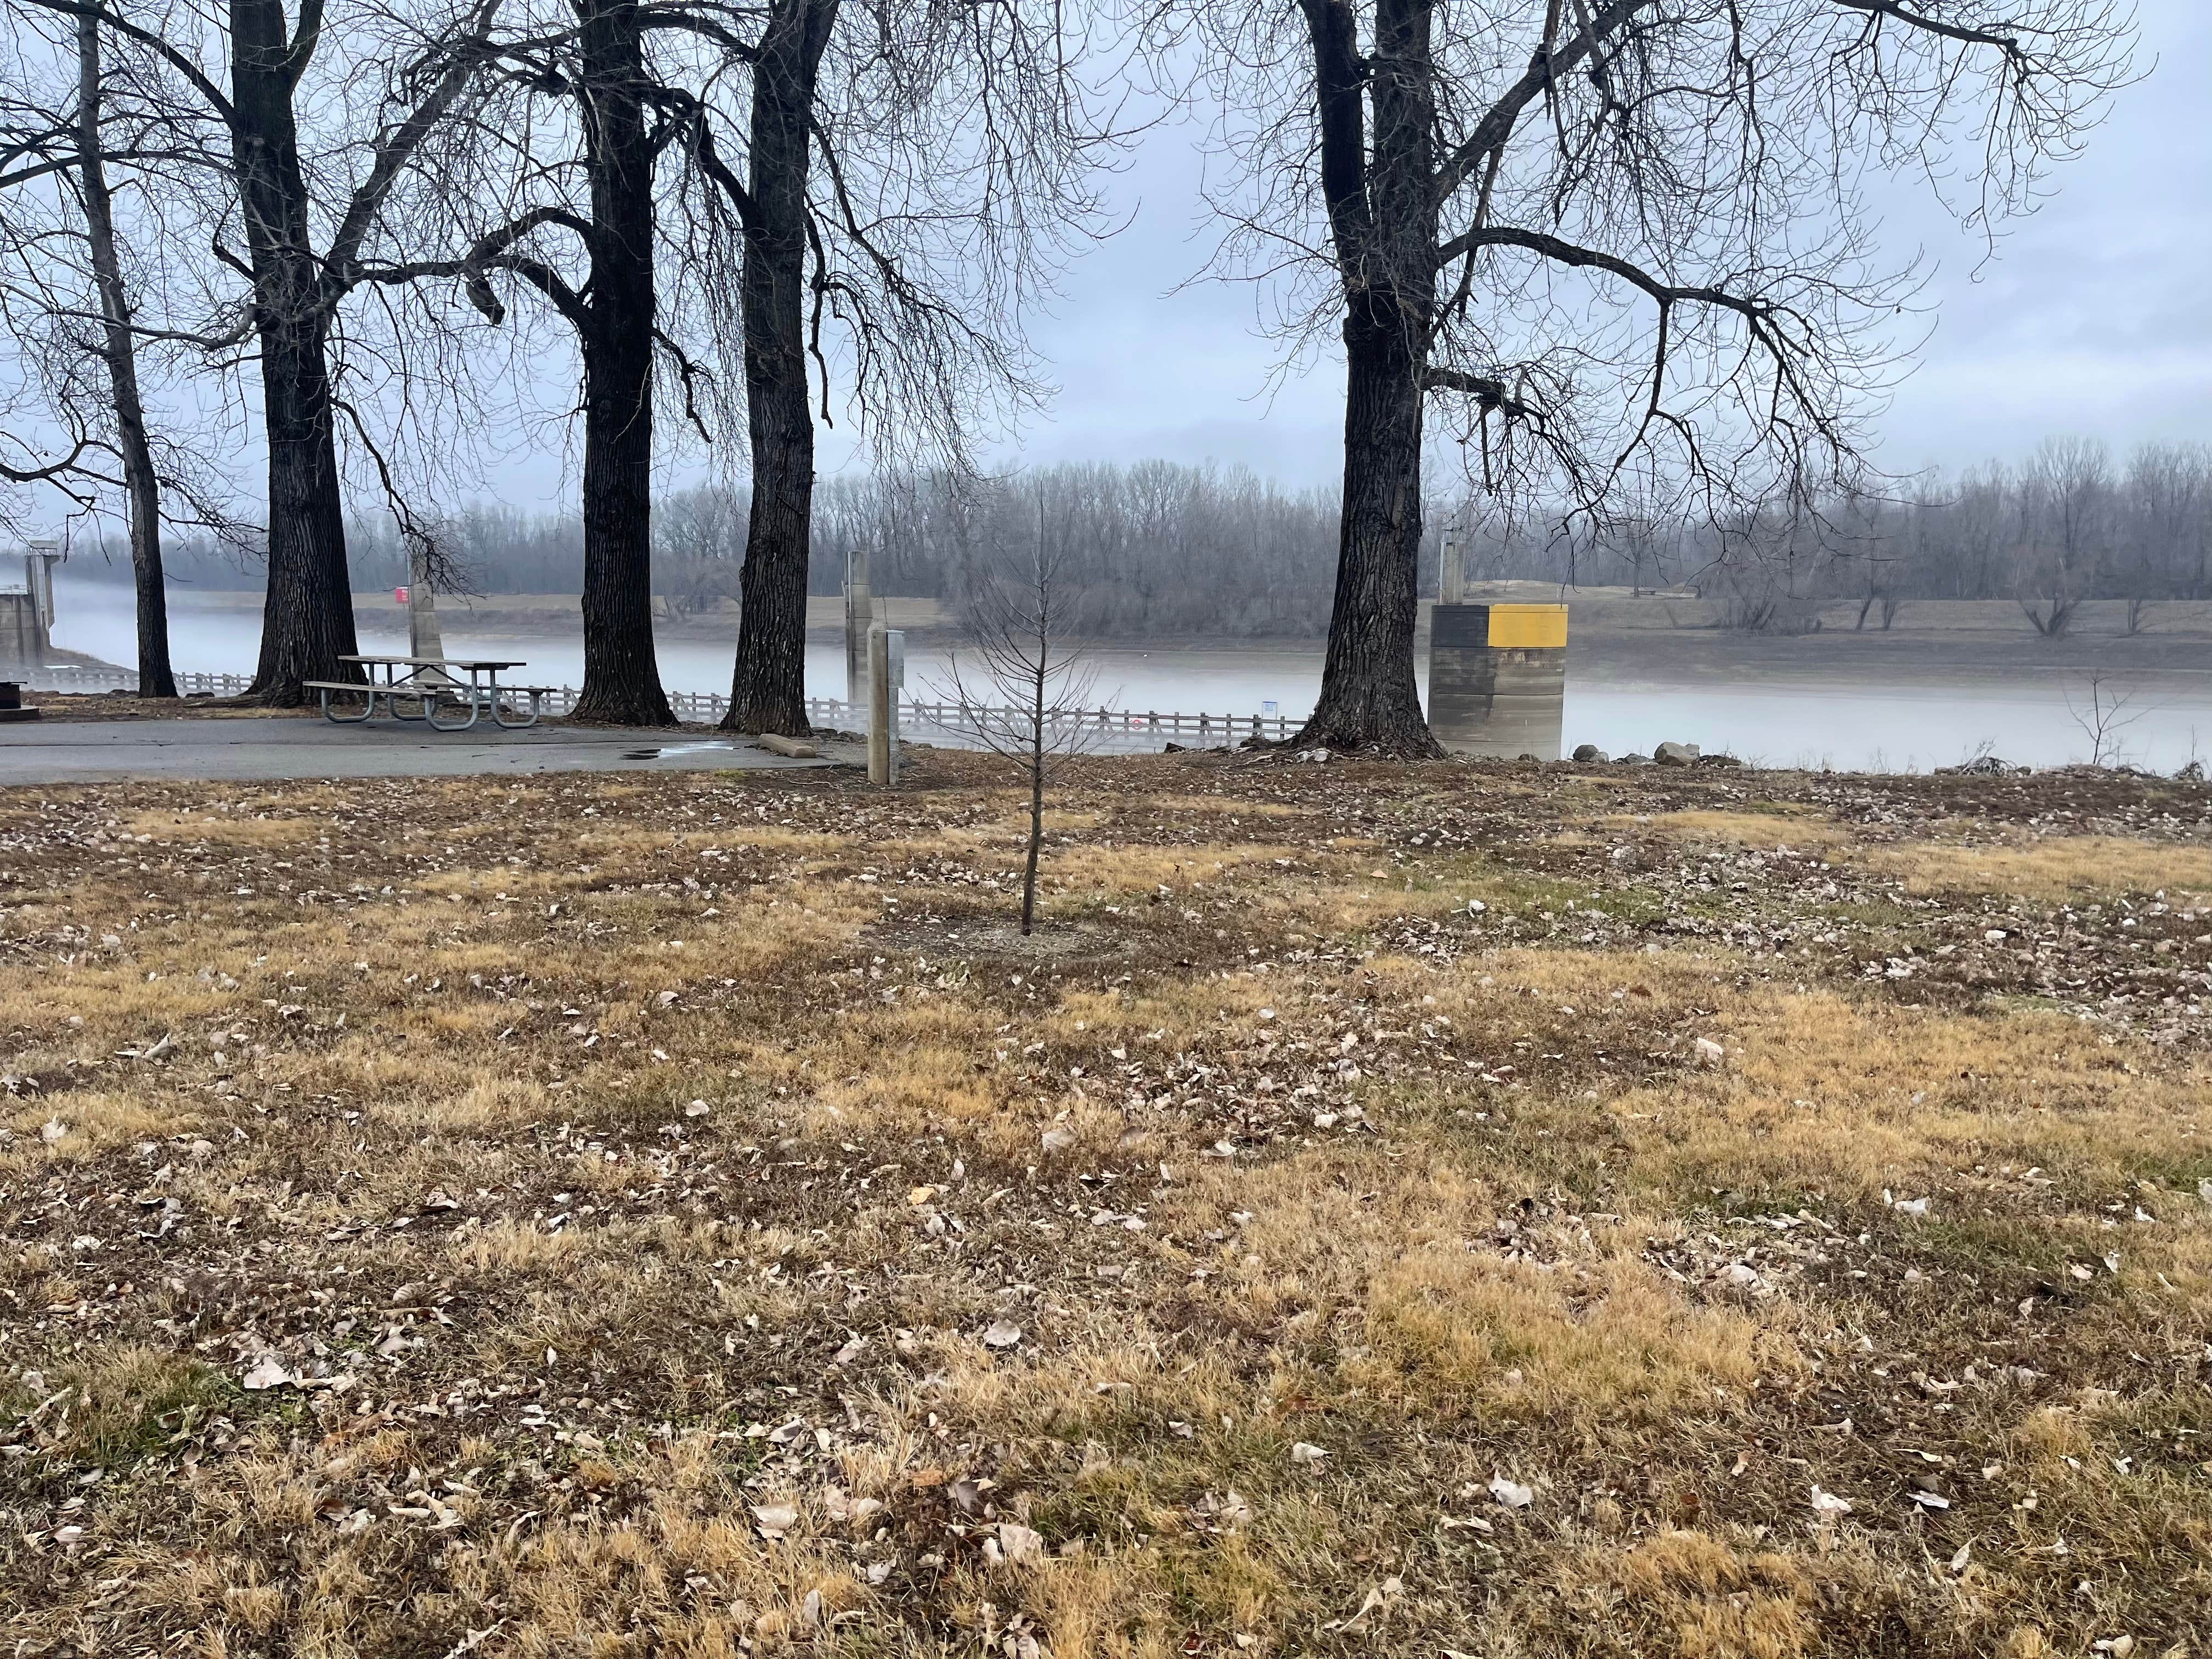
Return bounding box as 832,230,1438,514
1292,0,1442,757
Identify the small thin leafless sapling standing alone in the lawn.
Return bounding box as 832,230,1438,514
931,504,1097,934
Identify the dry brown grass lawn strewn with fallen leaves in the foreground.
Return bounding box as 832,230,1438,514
0,759,2212,1659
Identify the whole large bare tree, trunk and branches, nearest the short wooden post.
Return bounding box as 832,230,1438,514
695,0,1110,735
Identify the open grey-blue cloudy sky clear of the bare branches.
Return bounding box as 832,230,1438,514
951,0,2212,484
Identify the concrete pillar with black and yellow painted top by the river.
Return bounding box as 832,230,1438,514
1429,604,1566,761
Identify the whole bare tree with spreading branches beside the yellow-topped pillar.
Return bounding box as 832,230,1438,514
1132,0,2130,754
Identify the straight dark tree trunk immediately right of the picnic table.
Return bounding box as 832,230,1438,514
575,0,675,725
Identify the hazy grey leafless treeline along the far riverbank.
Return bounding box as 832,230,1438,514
64,440,2212,637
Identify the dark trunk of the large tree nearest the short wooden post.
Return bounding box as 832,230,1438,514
723,0,838,737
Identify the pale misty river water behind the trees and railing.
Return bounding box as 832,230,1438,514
55,582,2212,772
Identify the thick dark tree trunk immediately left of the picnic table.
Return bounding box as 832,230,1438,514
230,0,358,708
